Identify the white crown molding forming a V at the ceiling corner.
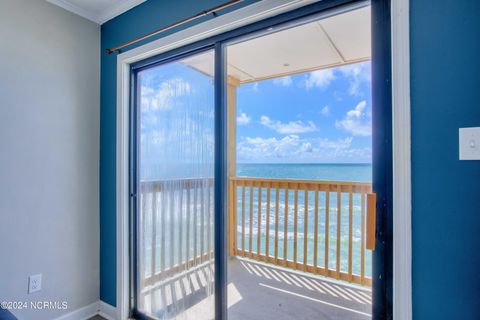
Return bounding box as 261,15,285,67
47,0,146,25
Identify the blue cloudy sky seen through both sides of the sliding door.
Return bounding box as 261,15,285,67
139,58,372,177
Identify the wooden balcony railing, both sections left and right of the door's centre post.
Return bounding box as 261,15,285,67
138,177,371,287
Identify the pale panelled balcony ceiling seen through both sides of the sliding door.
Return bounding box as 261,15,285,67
183,7,371,83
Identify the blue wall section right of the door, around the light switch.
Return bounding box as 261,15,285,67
410,0,480,320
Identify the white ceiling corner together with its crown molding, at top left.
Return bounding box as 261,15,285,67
47,0,146,24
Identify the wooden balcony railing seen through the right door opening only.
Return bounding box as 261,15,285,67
228,177,374,286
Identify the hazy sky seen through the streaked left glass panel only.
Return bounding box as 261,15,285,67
138,63,215,179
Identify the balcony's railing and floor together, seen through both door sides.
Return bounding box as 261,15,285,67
139,177,372,320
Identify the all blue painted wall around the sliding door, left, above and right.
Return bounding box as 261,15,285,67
100,0,480,320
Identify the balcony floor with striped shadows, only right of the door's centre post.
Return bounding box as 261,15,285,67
228,258,372,320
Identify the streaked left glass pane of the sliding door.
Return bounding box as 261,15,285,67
136,51,215,320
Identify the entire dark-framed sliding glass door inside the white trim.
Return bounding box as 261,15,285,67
129,0,392,320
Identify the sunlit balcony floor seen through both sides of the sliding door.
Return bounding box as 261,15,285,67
139,257,371,320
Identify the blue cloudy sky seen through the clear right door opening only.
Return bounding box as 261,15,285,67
237,62,372,163
